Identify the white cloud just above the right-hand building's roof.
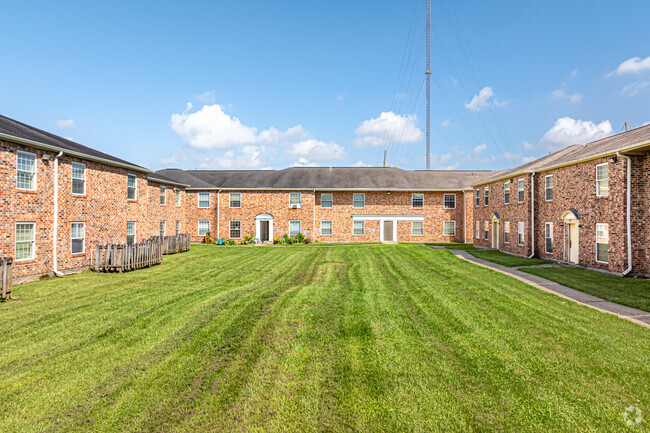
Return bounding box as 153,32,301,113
524,117,612,150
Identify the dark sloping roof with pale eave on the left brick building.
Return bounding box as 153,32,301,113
0,115,151,173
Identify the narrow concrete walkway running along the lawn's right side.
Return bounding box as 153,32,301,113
433,246,650,328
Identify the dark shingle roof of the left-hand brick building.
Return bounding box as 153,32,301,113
0,115,150,172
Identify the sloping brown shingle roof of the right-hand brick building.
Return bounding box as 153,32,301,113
472,125,650,186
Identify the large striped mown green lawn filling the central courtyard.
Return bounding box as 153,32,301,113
0,245,650,433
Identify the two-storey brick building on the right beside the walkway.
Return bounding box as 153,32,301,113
472,125,650,275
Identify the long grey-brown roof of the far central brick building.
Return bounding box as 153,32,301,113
156,167,492,191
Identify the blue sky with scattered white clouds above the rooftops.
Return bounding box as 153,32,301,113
0,0,650,169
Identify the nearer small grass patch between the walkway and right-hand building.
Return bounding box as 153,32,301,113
520,266,650,312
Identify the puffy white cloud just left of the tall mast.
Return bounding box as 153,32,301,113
354,111,424,147
